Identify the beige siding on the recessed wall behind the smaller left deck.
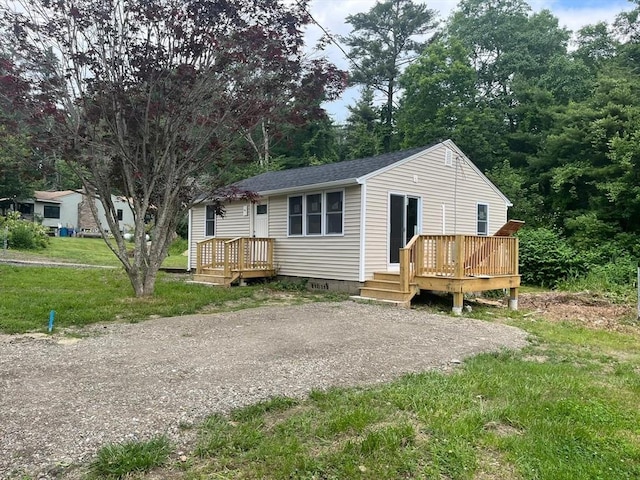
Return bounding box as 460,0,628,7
189,202,251,268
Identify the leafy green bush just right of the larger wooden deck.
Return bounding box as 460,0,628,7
518,228,587,288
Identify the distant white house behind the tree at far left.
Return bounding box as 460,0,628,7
10,190,134,236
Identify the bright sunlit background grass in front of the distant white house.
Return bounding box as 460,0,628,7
0,237,187,268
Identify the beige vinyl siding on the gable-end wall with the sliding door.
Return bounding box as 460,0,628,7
365,144,507,278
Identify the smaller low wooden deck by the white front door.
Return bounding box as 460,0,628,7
194,237,275,287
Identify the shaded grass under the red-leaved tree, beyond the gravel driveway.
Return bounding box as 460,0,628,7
0,265,259,333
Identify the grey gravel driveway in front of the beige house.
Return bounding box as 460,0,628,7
0,302,526,478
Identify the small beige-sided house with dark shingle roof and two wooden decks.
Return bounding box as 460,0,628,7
189,140,520,311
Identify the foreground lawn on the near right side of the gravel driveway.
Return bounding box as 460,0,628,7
172,316,640,480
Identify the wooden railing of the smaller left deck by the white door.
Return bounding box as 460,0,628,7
196,237,274,276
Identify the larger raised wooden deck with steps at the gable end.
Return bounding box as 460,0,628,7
360,235,520,314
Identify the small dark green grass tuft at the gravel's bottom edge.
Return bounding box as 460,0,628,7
89,436,171,480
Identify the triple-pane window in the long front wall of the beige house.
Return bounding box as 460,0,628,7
288,191,344,236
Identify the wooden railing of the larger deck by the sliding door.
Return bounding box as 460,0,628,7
400,235,518,292
